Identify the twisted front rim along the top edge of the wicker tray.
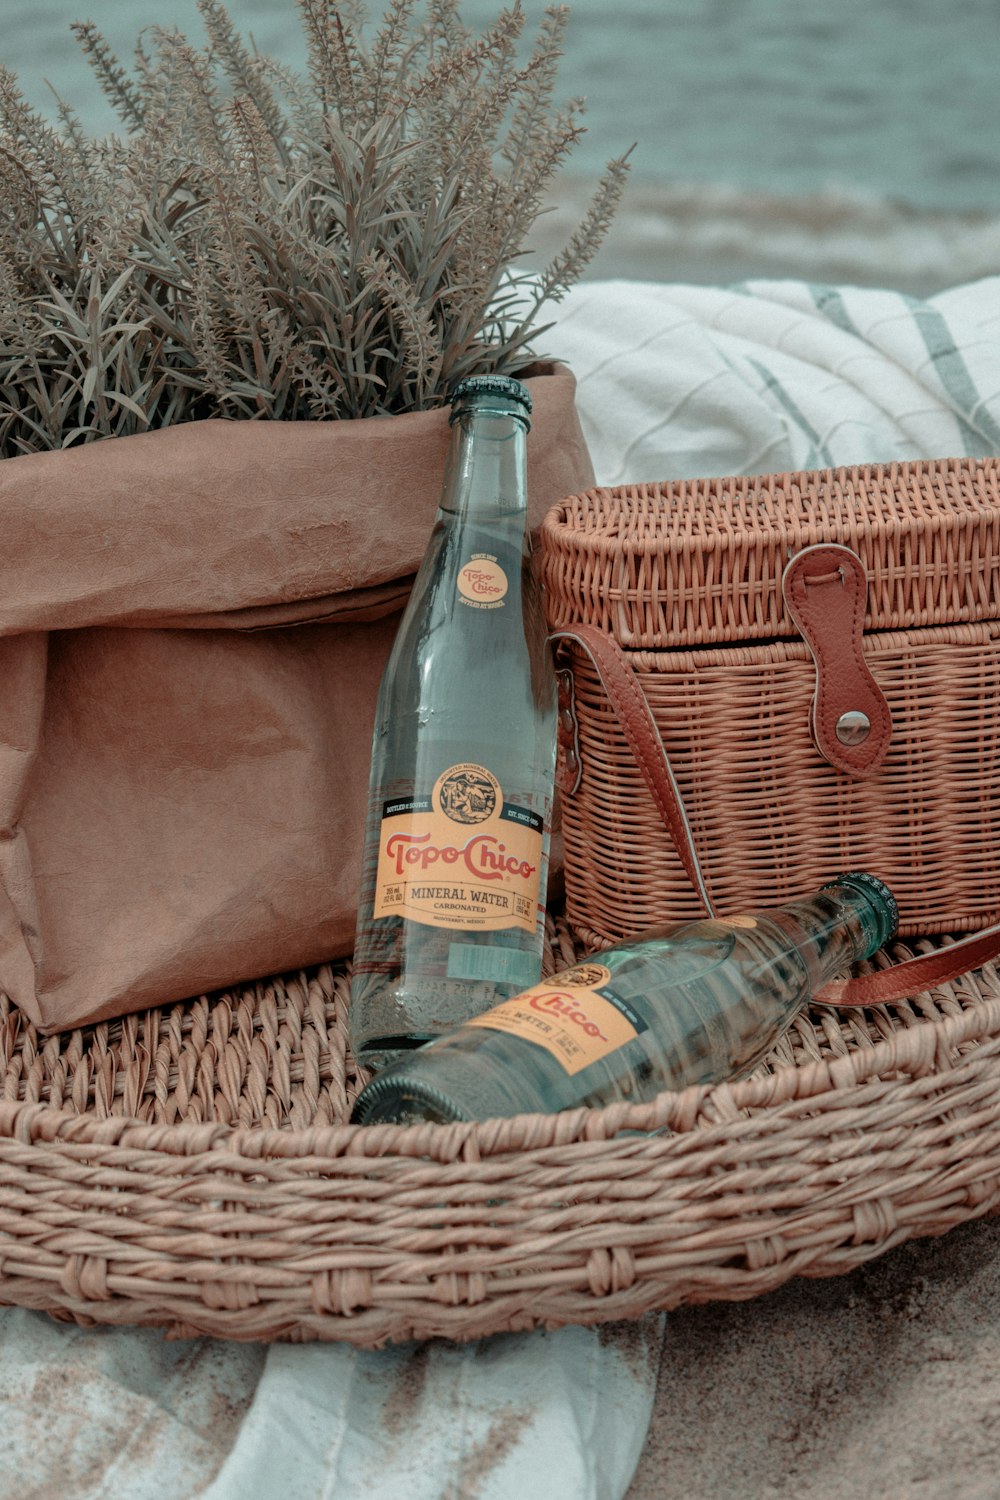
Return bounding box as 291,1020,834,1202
0,981,1000,1169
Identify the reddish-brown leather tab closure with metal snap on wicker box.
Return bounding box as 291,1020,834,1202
781,542,892,777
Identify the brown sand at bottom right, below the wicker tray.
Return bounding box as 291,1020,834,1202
627,1220,1000,1500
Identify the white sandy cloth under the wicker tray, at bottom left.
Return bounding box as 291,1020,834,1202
0,1308,663,1500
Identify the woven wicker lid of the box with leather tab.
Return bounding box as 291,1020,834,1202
541,459,1000,650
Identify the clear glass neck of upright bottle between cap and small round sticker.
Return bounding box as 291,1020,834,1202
441,407,528,525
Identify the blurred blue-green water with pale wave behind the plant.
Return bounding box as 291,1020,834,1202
7,0,1000,291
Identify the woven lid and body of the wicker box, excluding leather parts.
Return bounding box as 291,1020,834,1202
543,461,1000,944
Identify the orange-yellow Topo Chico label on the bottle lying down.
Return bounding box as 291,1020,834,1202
465,963,646,1074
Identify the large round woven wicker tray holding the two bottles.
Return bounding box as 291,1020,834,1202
0,918,1000,1346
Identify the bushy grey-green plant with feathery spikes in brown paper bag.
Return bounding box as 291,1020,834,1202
0,0,627,458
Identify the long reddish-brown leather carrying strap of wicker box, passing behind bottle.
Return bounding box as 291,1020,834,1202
552,626,1000,1005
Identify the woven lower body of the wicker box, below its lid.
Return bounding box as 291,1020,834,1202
562,624,1000,944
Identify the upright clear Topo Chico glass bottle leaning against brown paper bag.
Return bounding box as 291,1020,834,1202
349,375,556,1070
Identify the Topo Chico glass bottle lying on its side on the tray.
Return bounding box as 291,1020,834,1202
352,873,897,1125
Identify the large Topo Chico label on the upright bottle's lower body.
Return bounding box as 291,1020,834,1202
373,764,544,932
